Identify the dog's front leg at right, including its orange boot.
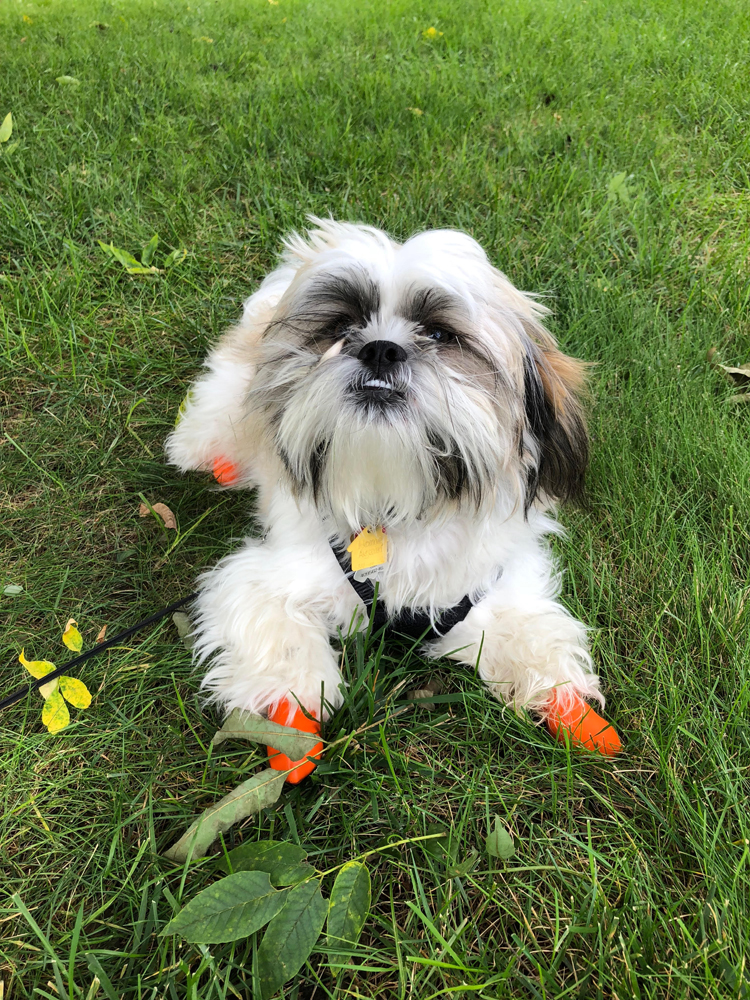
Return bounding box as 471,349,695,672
430,549,620,754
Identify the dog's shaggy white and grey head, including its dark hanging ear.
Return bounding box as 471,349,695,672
250,222,587,529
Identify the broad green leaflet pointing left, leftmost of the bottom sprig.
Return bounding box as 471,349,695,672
162,872,289,944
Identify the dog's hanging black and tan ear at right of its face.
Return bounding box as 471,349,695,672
524,331,589,510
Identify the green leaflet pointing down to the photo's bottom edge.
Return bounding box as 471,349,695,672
258,879,328,1000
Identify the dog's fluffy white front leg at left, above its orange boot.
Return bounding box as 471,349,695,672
195,539,357,721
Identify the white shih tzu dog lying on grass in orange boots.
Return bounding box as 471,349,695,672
166,219,620,754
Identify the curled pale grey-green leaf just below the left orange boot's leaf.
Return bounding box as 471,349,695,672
164,767,286,864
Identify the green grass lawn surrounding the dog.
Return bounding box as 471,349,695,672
0,0,750,1000
